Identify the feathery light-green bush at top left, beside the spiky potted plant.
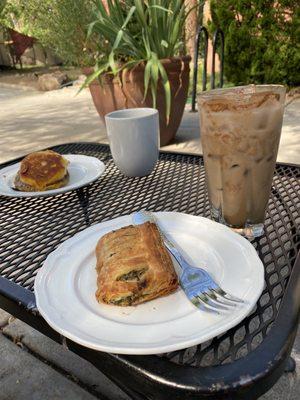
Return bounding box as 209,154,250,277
0,0,97,66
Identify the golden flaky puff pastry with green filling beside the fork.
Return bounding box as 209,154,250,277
96,222,178,306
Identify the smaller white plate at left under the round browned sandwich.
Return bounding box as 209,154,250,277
0,154,105,197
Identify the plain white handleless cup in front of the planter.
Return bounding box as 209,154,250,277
105,108,159,176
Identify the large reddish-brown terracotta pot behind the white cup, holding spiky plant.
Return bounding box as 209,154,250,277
83,56,191,146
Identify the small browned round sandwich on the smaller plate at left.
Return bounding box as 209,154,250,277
14,150,69,192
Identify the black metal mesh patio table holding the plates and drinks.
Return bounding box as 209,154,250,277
0,143,300,400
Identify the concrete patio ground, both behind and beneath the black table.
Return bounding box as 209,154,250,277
0,85,300,400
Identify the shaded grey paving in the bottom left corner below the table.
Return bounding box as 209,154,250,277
0,309,129,400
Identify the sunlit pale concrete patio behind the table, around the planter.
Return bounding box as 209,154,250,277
0,84,300,163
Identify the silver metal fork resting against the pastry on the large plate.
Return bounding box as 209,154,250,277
132,211,244,314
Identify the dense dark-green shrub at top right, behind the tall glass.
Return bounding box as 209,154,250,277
209,0,300,85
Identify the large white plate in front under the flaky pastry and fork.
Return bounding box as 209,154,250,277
34,212,264,354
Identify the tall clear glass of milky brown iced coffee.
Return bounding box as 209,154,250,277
198,85,285,236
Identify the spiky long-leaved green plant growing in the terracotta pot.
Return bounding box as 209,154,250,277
85,0,196,119
